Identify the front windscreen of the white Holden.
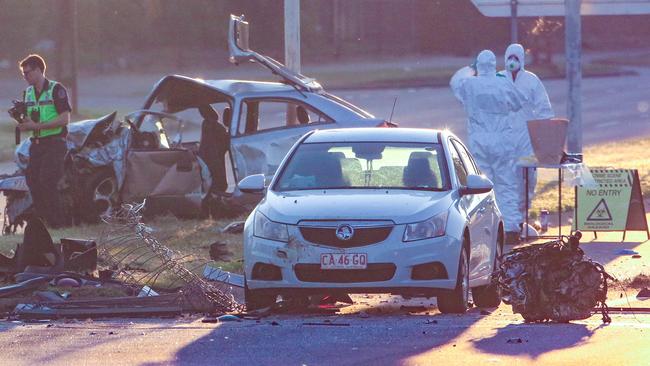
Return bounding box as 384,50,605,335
273,142,450,191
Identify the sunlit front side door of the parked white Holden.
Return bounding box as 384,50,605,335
451,139,497,277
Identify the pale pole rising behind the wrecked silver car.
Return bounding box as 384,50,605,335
284,0,300,125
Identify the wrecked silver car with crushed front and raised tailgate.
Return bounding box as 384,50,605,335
0,16,384,231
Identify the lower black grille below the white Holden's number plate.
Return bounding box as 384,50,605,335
294,263,396,283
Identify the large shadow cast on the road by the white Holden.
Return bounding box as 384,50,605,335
167,300,484,366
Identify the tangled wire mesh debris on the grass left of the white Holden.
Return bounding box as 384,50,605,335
98,202,244,312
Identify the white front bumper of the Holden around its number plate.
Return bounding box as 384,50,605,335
244,225,462,296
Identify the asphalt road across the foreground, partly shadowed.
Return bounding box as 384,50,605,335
0,302,650,366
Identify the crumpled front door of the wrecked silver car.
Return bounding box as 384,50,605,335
121,115,204,215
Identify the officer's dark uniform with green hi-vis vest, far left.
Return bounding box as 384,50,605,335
23,79,72,227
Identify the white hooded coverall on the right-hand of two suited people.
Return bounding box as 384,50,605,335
499,43,555,224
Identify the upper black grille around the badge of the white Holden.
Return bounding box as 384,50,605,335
300,226,393,248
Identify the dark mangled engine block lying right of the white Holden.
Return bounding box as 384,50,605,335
495,232,613,323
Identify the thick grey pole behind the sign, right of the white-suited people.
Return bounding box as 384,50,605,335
564,0,582,153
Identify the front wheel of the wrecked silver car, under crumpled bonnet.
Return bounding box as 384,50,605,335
82,169,118,222
